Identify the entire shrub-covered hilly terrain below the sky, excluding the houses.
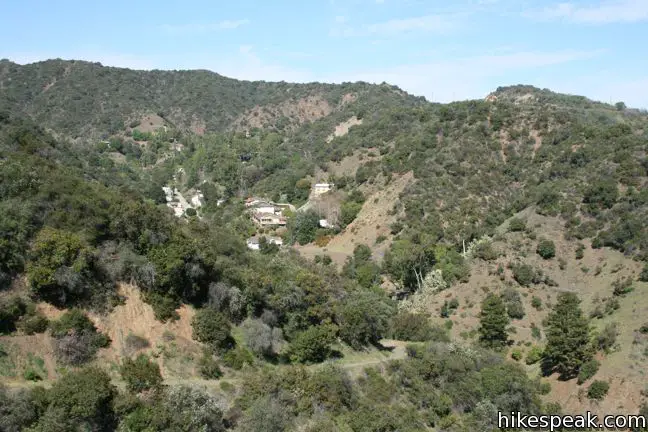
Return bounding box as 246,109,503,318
0,60,648,432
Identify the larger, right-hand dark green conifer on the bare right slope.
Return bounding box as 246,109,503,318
543,292,593,379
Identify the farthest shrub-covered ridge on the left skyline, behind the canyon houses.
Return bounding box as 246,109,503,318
0,60,422,138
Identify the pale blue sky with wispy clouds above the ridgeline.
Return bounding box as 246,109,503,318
0,0,648,108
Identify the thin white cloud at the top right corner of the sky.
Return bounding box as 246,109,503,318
523,0,648,24
